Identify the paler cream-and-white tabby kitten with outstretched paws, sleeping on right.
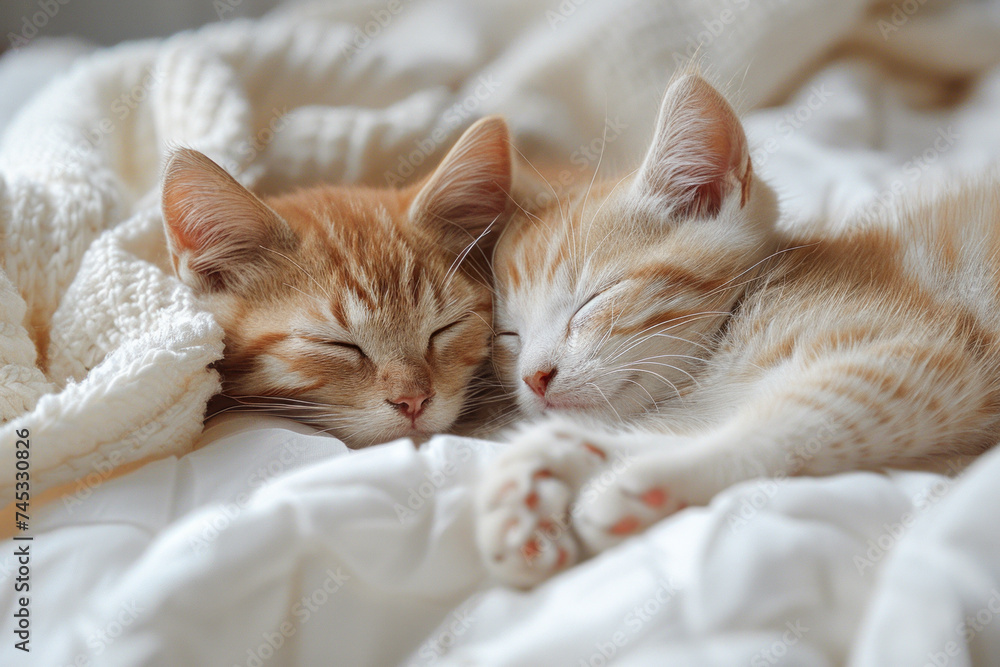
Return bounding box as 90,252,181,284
477,74,1000,585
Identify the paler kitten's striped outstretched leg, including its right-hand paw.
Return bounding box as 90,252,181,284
575,340,996,552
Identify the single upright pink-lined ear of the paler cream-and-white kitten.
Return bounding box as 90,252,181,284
635,74,753,216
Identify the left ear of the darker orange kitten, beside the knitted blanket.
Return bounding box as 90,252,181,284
163,148,297,291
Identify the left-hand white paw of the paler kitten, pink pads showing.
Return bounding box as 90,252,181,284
476,421,607,587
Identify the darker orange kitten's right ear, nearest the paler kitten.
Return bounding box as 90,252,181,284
410,116,511,247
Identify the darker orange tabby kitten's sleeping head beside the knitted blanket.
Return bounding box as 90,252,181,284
163,118,511,446
